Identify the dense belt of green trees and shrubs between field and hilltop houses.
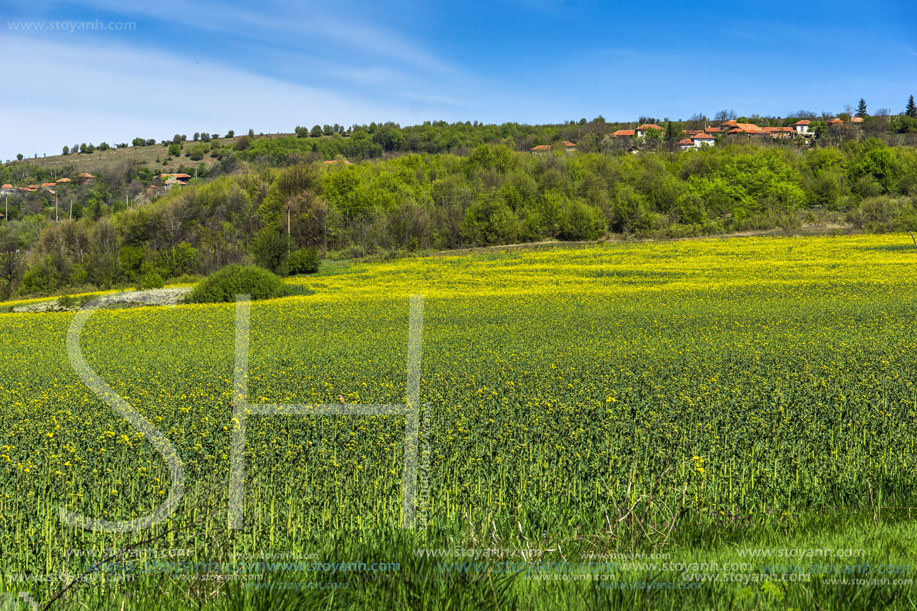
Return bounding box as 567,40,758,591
0,117,917,297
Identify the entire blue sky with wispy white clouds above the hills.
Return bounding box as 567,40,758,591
0,0,917,160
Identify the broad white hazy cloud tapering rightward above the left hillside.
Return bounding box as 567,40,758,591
0,37,411,159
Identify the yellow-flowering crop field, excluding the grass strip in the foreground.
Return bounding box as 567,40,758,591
0,235,917,604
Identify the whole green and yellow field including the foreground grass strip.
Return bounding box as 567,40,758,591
0,236,917,609
